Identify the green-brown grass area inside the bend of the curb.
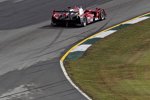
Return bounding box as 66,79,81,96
65,20,150,100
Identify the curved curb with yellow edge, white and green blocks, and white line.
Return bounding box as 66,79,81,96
60,13,150,100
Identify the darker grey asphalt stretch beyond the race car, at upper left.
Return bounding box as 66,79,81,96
0,0,112,29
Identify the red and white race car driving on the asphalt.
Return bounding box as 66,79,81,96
51,7,106,27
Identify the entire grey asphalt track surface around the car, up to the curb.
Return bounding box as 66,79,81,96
0,0,150,100
